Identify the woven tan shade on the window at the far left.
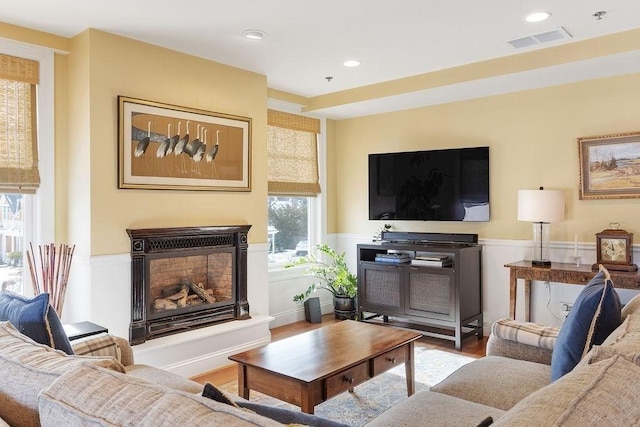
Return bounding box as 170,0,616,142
0,55,40,194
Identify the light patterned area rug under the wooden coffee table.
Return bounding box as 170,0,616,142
217,347,474,427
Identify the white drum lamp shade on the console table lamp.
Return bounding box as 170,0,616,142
518,190,564,222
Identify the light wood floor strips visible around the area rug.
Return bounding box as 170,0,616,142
191,314,487,385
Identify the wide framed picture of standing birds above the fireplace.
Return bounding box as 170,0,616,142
118,95,252,191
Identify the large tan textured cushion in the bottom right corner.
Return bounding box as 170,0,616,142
494,356,640,426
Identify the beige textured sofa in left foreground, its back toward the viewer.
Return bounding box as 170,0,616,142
0,322,290,427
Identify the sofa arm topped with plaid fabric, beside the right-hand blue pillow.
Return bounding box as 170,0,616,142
487,319,560,365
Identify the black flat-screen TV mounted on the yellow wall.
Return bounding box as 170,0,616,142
369,147,489,221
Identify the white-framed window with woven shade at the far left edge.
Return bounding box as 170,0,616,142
0,44,54,295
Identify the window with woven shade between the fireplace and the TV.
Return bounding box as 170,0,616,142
267,110,320,267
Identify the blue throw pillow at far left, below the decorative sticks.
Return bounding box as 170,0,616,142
0,292,73,354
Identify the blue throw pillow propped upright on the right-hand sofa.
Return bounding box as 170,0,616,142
551,268,622,381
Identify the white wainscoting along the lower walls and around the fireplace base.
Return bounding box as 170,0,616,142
63,239,640,376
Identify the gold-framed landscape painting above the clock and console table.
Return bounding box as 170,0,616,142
578,132,640,200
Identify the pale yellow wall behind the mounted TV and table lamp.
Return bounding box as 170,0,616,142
335,74,640,242
